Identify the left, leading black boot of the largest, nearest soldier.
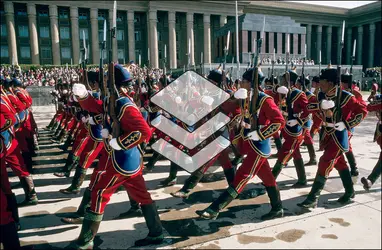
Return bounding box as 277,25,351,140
76,210,103,249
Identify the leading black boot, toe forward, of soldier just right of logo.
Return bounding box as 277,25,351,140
196,187,238,220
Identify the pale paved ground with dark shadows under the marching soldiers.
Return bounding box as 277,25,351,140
10,102,381,249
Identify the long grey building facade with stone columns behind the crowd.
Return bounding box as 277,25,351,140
0,1,382,69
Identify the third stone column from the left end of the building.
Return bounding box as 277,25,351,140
49,5,61,65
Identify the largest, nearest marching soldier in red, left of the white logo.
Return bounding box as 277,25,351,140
69,65,163,249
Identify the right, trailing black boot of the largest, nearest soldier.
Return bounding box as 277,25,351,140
135,202,164,247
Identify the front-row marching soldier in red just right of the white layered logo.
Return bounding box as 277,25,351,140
196,69,285,220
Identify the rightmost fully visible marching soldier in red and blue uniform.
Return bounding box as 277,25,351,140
297,68,367,208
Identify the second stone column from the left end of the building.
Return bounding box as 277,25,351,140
27,3,40,64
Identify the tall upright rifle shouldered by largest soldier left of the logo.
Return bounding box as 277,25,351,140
108,1,121,138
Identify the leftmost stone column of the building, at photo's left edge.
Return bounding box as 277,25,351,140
4,2,18,64
